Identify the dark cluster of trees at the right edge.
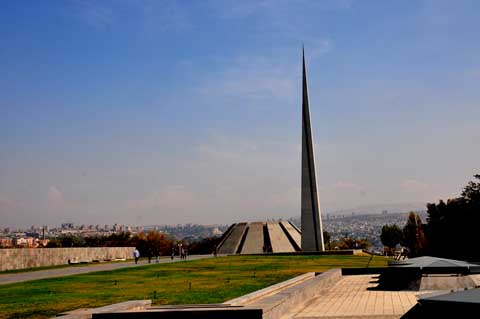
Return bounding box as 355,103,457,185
381,175,480,261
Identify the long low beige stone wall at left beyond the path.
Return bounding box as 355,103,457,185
0,247,135,271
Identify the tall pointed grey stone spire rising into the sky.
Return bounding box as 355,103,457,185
302,50,325,251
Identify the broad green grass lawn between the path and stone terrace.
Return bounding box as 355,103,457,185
0,256,387,318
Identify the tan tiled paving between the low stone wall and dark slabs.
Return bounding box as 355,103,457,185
294,275,434,319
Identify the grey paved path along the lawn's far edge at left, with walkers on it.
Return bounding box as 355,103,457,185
0,255,212,285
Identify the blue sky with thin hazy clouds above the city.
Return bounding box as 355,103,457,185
0,0,480,227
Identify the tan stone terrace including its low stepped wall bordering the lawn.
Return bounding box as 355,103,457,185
65,269,429,319
